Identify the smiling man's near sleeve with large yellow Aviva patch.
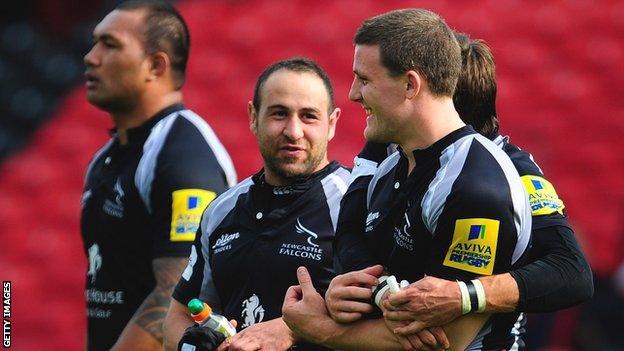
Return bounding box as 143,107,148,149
425,158,531,280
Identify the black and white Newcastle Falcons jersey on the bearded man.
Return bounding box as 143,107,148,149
173,162,351,350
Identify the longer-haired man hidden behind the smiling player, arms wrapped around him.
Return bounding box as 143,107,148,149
326,33,593,350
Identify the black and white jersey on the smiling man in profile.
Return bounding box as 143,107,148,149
365,126,531,350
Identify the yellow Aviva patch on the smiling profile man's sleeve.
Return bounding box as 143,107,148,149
444,218,500,275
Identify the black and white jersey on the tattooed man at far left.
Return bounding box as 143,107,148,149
81,105,236,350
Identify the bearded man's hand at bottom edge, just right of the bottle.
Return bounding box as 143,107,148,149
217,318,295,351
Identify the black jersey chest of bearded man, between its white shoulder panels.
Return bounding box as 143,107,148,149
208,189,334,321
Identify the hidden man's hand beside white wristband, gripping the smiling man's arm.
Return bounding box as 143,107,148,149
383,276,462,335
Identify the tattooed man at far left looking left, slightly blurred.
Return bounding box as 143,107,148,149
81,1,236,350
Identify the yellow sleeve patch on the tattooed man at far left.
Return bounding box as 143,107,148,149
169,189,217,241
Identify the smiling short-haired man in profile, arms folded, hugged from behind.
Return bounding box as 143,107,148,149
284,9,531,350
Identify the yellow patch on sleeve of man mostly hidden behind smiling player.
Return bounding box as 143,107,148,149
520,175,565,216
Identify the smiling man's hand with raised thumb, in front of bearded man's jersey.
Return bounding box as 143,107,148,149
282,267,339,344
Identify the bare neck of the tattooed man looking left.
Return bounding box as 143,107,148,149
111,90,182,145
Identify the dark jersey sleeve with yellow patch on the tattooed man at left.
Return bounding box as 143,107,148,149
150,118,228,258
